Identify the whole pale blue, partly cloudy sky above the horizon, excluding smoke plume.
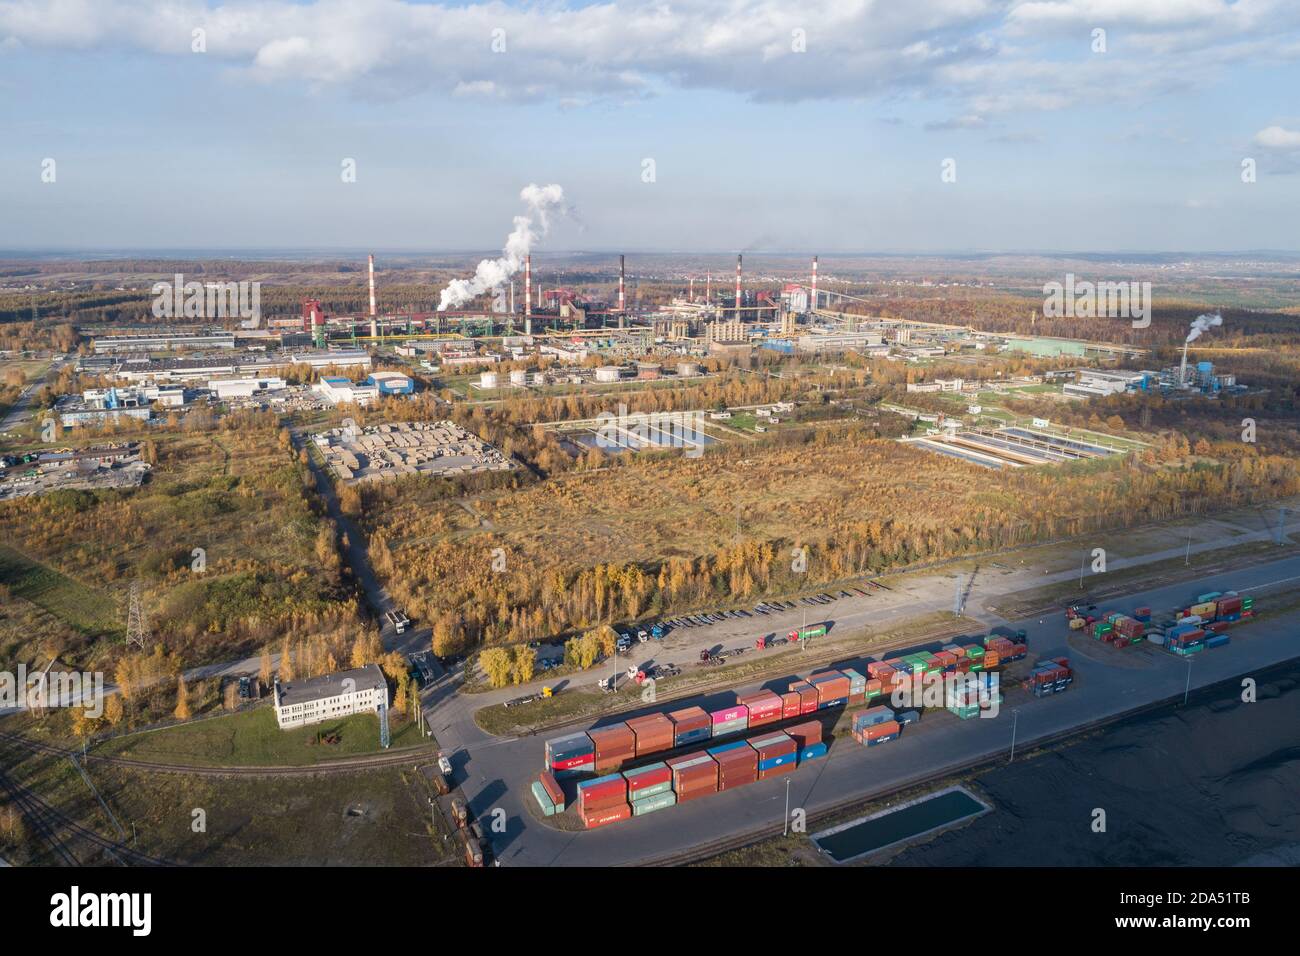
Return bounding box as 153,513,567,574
0,0,1300,254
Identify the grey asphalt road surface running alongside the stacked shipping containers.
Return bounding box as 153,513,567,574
426,558,1300,866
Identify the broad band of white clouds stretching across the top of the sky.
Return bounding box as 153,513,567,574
0,0,1300,122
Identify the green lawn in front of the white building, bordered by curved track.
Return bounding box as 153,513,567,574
94,706,424,766
